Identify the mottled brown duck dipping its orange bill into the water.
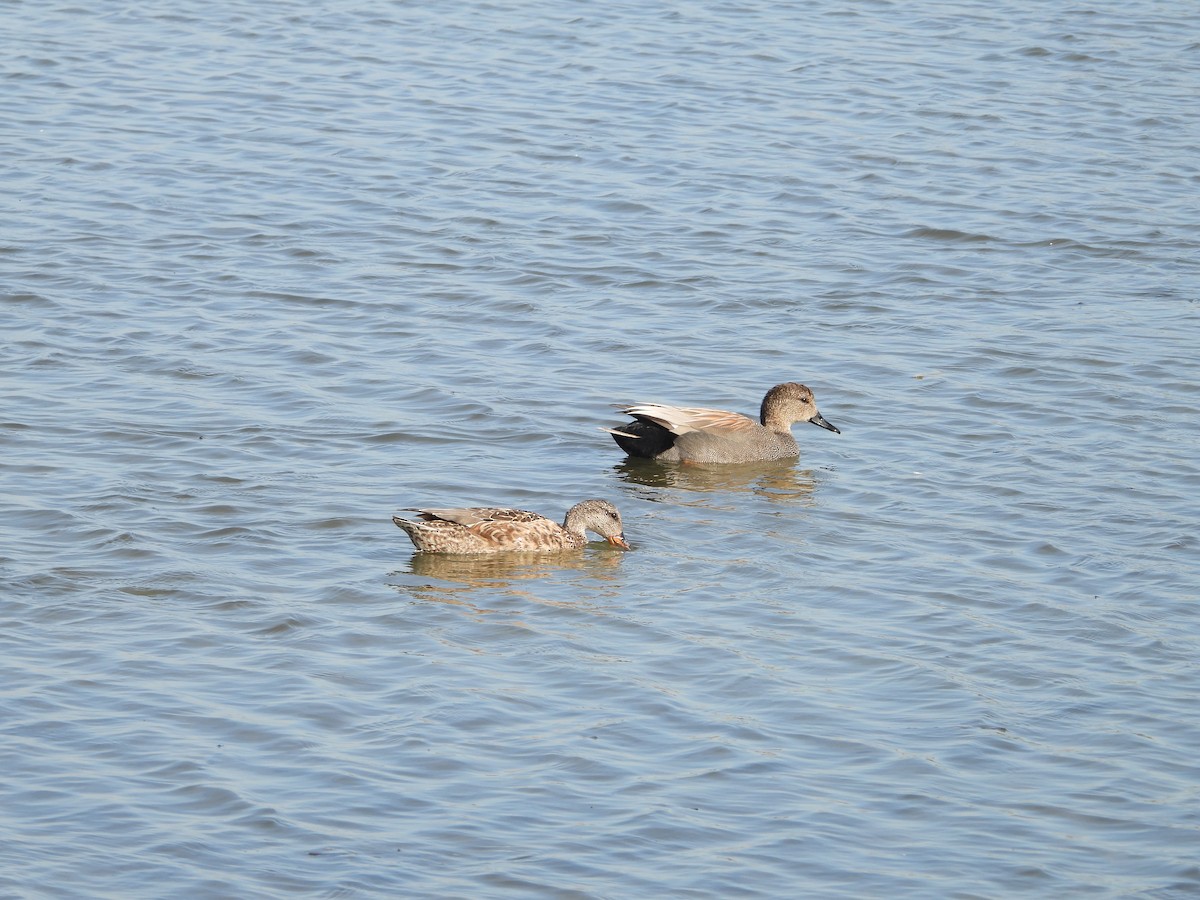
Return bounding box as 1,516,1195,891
391,500,629,553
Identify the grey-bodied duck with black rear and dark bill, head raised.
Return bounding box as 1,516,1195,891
605,382,841,462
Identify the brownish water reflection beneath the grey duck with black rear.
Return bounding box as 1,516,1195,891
613,458,816,500
